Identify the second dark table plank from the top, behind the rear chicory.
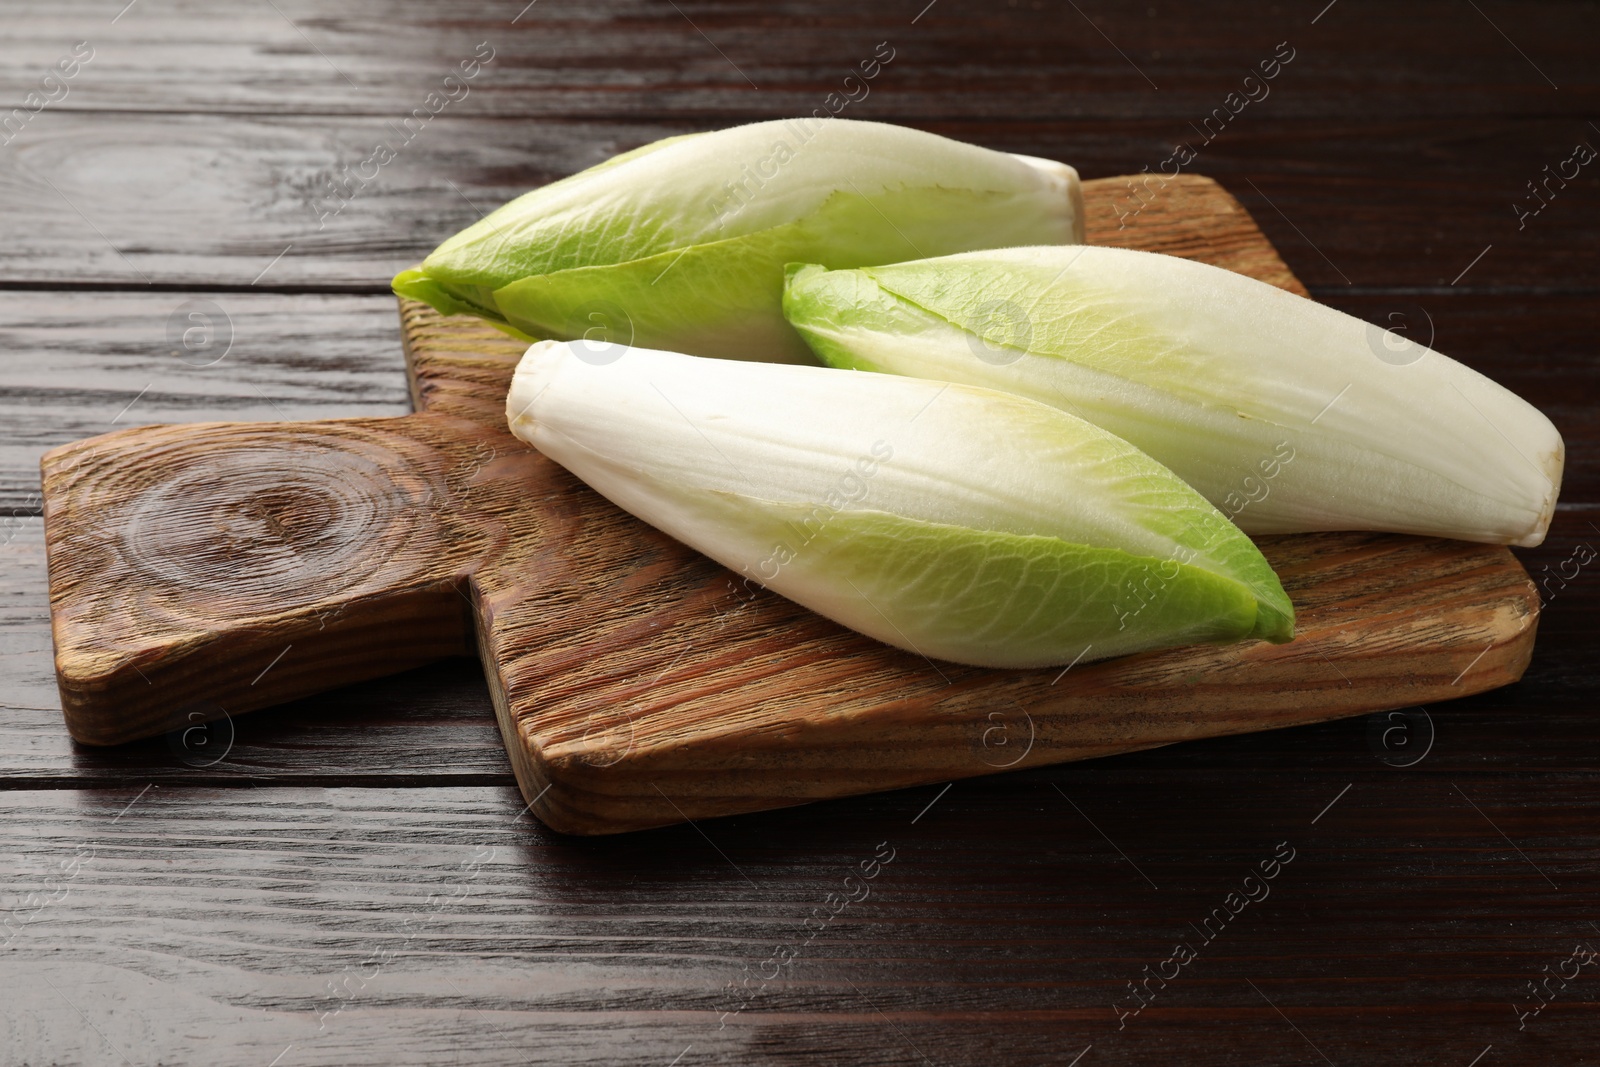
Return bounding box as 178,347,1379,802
0,112,1600,294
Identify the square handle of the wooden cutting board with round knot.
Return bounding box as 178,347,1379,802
42,414,528,744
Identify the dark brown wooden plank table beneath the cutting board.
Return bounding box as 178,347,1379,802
0,0,1600,1067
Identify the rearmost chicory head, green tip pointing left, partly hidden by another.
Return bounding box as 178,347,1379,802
394,118,1083,363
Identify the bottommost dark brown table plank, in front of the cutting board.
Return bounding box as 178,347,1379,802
0,780,1600,1067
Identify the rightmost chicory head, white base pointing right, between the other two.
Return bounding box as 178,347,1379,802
784,246,1563,545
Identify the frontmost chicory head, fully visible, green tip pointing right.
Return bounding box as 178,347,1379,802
507,341,1294,667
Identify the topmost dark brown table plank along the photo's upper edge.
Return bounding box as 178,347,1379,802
0,0,1600,122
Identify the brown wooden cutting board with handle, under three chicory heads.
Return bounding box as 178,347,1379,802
43,176,1538,833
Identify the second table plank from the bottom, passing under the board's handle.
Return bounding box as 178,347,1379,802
0,506,1600,780
